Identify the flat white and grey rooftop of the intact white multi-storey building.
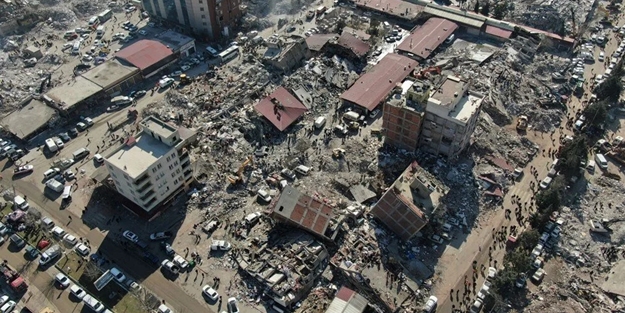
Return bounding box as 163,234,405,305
106,134,171,178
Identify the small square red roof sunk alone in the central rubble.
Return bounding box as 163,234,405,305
254,87,308,131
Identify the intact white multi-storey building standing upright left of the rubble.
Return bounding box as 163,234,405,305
105,117,196,213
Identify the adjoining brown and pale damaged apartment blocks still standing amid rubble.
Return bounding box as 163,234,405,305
382,73,484,158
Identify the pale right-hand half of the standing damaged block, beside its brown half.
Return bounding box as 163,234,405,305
419,76,484,158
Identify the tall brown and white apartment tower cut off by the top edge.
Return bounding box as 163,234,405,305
142,0,242,39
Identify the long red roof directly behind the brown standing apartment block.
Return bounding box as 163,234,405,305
341,53,418,111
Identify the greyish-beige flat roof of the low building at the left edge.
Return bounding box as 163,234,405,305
1,99,55,139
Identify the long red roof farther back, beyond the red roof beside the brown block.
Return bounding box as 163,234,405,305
397,17,458,59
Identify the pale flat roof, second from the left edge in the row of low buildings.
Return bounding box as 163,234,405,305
46,76,102,110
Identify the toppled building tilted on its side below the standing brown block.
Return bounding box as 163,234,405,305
371,162,449,240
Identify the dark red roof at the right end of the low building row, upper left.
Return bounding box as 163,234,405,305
115,39,173,70
